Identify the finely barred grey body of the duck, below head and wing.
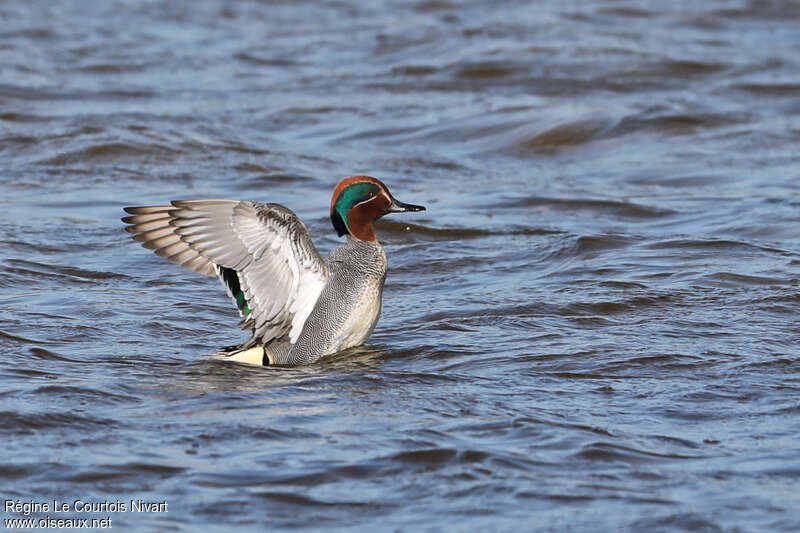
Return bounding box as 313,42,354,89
264,237,387,366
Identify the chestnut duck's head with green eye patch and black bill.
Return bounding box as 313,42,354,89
331,176,425,242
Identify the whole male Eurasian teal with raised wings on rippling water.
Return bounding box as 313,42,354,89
122,176,425,366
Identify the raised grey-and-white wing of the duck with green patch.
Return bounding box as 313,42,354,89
122,200,328,344
